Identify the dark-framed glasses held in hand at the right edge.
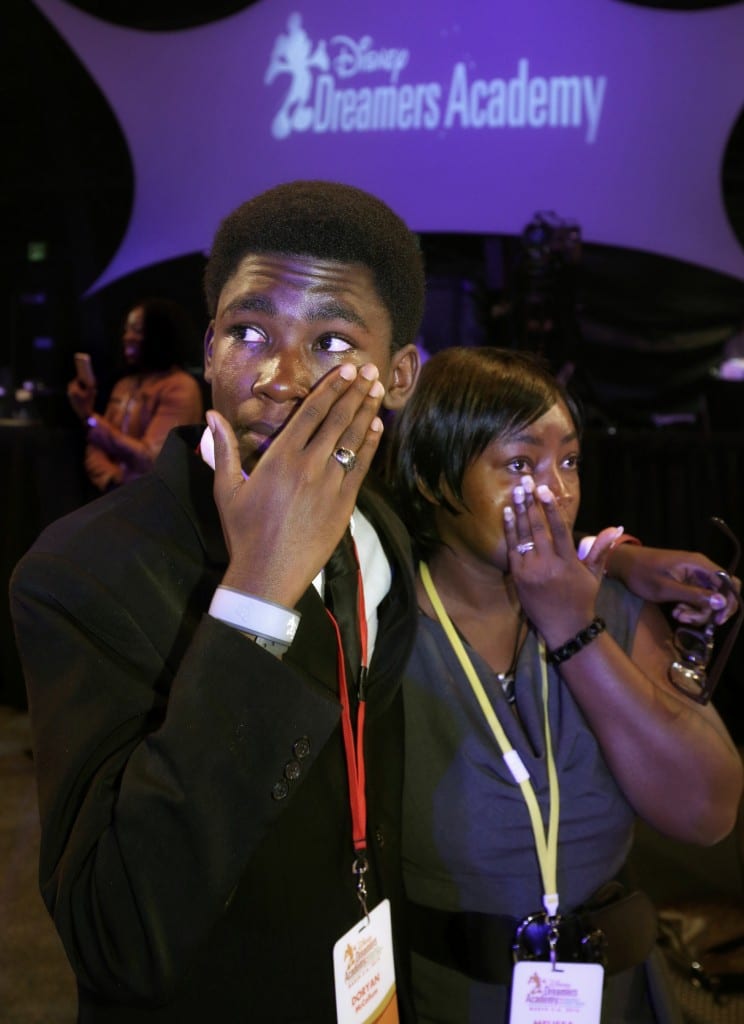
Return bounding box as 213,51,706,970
668,516,744,703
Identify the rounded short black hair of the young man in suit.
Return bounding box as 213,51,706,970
204,181,425,351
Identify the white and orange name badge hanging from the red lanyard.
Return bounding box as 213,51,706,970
334,899,398,1024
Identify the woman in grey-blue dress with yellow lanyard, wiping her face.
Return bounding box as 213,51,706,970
390,348,742,1024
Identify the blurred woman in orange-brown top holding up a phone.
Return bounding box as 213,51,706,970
68,298,204,492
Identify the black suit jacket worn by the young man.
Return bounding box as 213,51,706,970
11,431,415,1024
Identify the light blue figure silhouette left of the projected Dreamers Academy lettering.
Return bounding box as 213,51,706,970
264,13,329,138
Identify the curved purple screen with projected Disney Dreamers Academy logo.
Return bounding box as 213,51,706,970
35,0,744,287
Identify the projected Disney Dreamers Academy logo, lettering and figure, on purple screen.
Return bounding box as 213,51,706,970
264,12,607,143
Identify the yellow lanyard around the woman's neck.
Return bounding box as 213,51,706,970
419,562,561,918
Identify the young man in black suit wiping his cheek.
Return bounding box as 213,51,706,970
13,182,424,1024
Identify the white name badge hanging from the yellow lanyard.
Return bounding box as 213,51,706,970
509,961,605,1024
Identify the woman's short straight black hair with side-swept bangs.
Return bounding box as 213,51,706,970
387,347,582,558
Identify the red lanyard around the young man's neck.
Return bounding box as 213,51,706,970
326,544,368,854
